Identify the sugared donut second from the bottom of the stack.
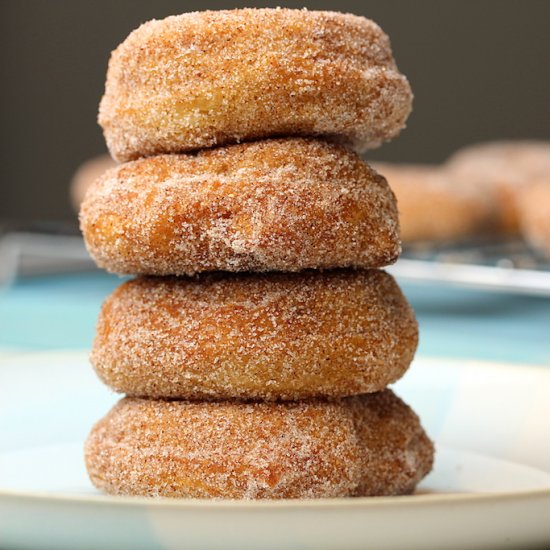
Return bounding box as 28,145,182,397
91,270,418,399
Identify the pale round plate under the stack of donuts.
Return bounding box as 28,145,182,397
0,352,550,550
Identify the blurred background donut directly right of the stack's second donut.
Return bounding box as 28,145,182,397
373,163,497,244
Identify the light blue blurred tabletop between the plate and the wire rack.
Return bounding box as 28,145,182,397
0,272,550,366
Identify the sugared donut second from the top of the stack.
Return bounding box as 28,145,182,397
80,138,400,275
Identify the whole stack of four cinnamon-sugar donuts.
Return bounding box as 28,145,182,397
80,9,433,499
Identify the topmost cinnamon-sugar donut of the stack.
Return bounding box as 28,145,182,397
99,9,412,161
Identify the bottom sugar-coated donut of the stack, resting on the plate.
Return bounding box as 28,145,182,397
85,390,433,499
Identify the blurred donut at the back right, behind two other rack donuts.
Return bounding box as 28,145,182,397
445,141,550,234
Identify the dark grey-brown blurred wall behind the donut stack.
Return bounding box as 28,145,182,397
0,0,550,222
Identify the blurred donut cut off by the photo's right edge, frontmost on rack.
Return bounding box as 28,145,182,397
519,181,550,258
